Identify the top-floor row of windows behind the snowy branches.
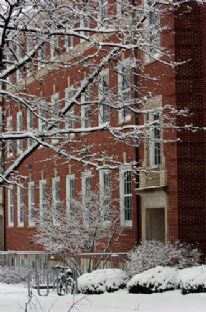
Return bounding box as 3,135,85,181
5,0,161,85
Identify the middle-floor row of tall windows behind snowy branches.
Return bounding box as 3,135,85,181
7,60,131,156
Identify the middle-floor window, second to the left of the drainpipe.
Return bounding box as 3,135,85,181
99,70,110,124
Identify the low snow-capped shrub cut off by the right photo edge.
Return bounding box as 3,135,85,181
178,265,206,294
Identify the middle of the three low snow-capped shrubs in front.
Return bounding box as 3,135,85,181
127,266,178,294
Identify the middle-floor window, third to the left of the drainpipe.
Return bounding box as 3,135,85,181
81,84,91,128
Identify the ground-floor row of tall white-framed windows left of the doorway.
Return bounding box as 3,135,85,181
8,170,132,227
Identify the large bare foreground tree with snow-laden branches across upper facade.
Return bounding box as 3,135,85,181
0,0,196,183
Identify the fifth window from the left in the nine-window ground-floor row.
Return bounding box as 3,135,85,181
52,177,60,225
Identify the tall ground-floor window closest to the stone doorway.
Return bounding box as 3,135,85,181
120,170,132,226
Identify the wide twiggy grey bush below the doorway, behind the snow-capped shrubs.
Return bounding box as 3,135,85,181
127,240,200,276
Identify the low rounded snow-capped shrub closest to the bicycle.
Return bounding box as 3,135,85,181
78,269,128,294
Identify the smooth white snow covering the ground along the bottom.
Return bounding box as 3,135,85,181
0,284,206,312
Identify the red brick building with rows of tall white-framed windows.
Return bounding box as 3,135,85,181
0,2,206,268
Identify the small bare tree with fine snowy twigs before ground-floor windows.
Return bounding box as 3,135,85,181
33,189,122,272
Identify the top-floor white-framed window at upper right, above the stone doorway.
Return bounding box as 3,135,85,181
144,0,161,64
